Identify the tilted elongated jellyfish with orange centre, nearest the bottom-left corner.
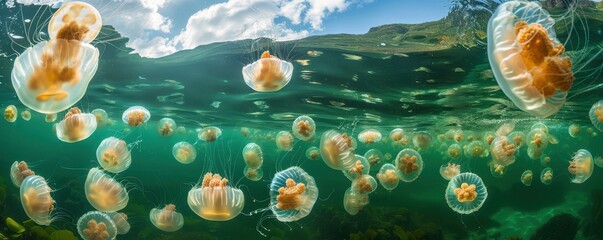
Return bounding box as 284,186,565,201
20,175,55,226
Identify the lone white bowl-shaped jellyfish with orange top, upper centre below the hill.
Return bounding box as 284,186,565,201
243,51,293,92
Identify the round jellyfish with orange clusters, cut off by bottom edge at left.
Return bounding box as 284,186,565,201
77,211,117,240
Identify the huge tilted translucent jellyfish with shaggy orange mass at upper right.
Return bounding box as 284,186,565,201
488,1,574,118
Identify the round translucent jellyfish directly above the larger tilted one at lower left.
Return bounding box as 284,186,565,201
96,137,132,173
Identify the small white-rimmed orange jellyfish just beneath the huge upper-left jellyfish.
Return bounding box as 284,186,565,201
56,108,96,143
